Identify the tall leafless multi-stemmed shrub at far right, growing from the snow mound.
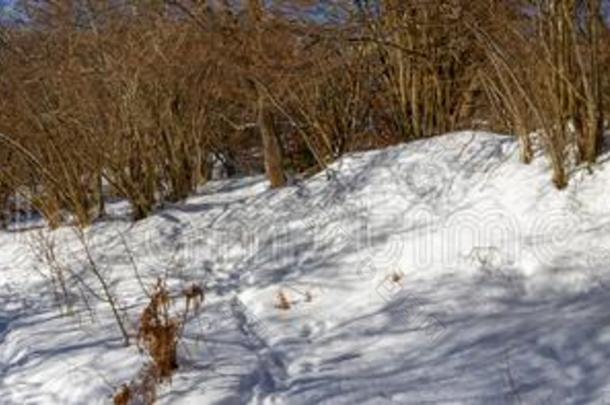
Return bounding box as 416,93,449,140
470,0,608,188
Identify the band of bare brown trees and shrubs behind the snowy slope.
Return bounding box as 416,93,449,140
0,0,610,227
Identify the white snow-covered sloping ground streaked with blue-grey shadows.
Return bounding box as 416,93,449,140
0,132,610,405
